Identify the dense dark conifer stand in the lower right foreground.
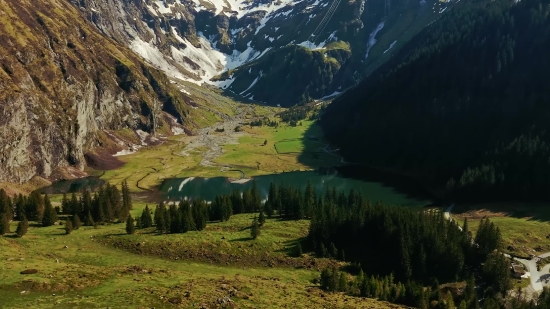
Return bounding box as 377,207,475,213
308,184,510,309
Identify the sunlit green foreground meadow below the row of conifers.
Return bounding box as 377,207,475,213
0,204,404,308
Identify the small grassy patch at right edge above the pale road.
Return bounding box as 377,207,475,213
453,203,550,256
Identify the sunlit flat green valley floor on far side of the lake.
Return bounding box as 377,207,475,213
97,114,339,192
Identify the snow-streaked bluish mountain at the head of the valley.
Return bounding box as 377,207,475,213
72,0,453,106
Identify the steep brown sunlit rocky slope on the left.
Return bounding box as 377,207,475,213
0,0,191,182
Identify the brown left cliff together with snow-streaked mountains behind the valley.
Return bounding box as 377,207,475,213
0,0,451,183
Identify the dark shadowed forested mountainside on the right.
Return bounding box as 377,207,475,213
321,0,550,201
